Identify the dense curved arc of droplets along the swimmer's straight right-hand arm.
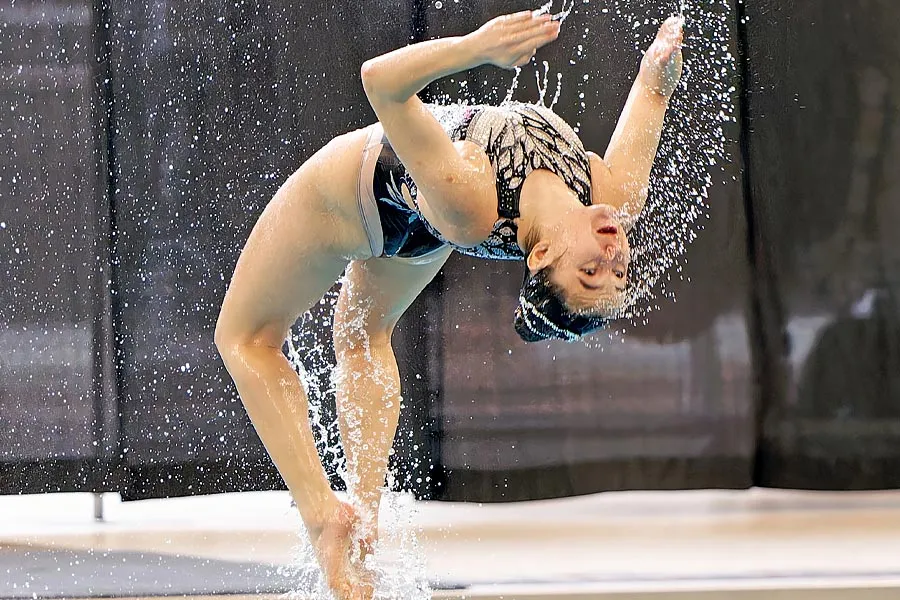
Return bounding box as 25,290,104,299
615,0,736,324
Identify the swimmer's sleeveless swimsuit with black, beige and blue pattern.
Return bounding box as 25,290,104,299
372,103,591,260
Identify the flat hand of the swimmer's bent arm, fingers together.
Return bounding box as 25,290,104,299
465,10,560,69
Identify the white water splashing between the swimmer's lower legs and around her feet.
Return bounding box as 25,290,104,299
283,276,432,600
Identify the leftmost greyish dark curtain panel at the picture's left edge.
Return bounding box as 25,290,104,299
0,1,117,493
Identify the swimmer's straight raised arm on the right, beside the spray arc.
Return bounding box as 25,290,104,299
591,17,683,223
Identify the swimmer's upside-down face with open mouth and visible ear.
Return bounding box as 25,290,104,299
529,204,631,316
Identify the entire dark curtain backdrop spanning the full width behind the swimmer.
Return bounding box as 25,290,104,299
0,0,900,502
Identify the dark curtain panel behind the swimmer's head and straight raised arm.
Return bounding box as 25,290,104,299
418,2,755,502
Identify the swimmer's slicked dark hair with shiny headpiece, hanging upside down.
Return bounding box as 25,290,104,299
515,269,609,342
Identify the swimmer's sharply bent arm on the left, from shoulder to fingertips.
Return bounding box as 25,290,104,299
361,11,559,245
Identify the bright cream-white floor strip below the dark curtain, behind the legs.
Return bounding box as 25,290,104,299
0,490,900,600
